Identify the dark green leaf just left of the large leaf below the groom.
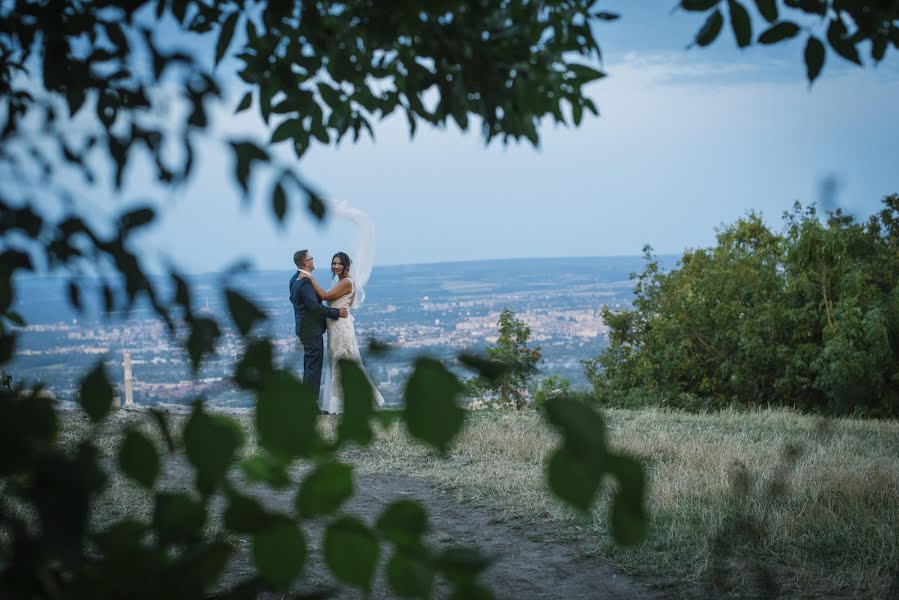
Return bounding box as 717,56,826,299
184,402,244,495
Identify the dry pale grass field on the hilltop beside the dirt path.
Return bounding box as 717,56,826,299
52,410,899,598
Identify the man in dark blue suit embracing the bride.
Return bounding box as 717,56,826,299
290,250,348,401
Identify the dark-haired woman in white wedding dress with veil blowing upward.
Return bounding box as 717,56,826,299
301,202,384,414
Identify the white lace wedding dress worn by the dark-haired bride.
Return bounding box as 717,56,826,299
321,278,384,414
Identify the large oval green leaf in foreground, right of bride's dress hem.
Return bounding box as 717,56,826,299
404,358,465,454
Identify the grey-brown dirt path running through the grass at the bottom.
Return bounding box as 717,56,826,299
204,466,664,600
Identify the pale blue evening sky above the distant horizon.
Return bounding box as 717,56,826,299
37,0,899,272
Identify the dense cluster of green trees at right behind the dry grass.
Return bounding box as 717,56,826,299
586,195,899,416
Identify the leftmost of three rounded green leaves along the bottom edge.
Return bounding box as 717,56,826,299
253,519,307,589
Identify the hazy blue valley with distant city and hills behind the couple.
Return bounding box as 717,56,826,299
7,257,674,407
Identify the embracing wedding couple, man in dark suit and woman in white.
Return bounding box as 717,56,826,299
290,205,384,414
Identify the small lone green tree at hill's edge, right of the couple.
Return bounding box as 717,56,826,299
475,308,540,410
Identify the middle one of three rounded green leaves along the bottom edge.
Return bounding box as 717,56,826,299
324,517,379,592
